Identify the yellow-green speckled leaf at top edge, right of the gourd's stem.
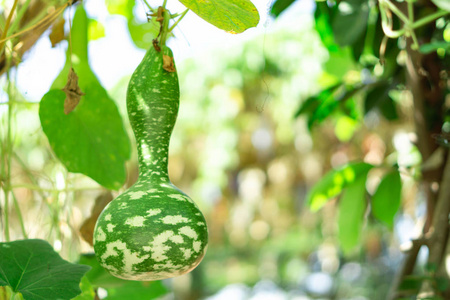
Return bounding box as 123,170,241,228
180,0,259,33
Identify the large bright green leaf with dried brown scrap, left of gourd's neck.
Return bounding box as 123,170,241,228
39,5,130,189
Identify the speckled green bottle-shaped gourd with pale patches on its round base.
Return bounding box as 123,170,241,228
94,47,208,280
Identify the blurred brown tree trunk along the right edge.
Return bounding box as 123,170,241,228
389,1,450,299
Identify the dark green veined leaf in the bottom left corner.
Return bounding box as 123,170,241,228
0,239,90,300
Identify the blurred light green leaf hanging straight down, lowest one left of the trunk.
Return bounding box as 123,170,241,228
338,172,367,253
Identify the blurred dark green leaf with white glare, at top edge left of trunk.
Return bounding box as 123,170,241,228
332,0,369,47
